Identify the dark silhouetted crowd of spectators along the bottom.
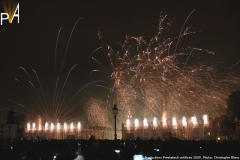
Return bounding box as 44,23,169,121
0,138,240,160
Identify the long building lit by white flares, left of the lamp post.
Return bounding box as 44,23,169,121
25,122,122,139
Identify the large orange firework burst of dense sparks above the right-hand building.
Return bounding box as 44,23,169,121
86,10,240,121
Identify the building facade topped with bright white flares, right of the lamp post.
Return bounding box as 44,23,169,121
122,115,216,140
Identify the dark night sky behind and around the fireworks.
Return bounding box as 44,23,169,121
0,0,240,123
